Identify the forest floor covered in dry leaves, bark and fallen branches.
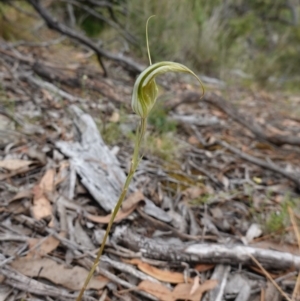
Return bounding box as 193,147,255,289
0,5,300,301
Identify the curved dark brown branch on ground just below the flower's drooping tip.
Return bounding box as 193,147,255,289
169,92,300,146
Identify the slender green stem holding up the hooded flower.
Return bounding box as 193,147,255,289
76,118,147,301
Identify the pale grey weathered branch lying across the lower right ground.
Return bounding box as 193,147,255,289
113,227,300,270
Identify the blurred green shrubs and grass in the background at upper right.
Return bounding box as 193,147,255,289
120,0,300,88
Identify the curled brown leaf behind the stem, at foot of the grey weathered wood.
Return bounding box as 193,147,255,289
87,191,144,224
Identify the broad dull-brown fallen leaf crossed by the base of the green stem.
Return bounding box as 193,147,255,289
11,258,108,291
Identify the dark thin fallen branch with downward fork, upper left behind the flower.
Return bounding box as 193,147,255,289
27,0,144,75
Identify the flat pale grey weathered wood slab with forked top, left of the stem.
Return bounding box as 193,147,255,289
56,106,126,211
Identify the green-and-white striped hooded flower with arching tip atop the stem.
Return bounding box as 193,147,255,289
131,62,204,118
